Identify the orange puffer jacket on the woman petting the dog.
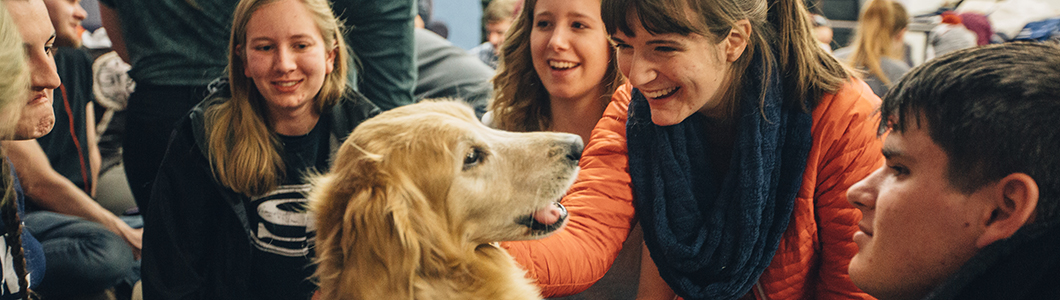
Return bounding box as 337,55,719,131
502,80,883,299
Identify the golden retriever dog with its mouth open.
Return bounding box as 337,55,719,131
310,102,582,299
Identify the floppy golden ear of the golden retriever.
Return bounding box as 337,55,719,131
310,141,411,299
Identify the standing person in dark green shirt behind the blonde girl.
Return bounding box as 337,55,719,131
99,0,417,211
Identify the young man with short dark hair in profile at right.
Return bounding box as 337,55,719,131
847,43,1060,299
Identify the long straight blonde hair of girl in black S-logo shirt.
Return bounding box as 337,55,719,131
206,0,349,196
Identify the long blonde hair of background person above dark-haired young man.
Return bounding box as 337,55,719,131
847,0,909,87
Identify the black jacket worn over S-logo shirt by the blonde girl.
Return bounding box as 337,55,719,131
141,87,379,299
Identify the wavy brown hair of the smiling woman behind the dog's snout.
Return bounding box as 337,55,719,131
490,0,623,131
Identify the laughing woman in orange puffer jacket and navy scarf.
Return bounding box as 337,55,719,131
507,0,883,299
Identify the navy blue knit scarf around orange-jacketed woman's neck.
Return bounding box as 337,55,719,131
626,57,813,299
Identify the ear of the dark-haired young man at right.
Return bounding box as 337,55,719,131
975,173,1038,248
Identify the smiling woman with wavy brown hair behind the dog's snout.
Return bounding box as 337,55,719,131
484,0,622,146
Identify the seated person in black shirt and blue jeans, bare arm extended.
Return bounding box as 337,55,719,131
3,0,143,298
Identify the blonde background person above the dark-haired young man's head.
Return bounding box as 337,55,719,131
835,0,909,96
